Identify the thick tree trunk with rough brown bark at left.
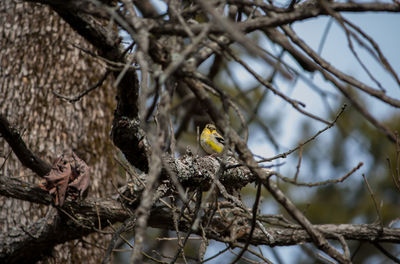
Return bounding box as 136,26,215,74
0,0,117,263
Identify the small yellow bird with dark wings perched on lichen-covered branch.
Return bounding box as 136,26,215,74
200,124,224,154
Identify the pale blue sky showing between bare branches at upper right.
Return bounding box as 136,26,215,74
248,13,400,156
